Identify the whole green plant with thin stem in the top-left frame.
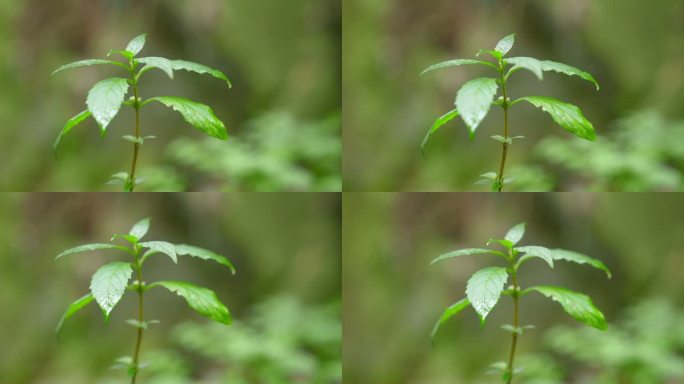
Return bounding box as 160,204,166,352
52,34,231,192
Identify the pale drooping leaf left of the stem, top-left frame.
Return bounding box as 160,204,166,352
86,77,128,133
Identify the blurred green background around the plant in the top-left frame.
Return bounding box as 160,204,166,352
0,0,342,191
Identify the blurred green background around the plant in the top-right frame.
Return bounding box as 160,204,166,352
342,0,684,192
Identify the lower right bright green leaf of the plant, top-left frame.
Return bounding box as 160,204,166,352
150,96,228,140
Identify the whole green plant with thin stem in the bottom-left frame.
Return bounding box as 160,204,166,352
55,219,235,383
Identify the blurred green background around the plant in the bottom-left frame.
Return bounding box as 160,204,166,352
0,193,342,384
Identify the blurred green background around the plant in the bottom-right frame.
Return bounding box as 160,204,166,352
342,193,684,384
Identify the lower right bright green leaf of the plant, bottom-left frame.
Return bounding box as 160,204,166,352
149,281,232,325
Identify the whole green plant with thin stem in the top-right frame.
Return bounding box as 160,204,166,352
421,34,599,192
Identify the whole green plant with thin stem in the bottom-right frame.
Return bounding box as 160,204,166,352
431,223,611,384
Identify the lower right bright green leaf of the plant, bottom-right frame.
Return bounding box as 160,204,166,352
527,286,608,331
